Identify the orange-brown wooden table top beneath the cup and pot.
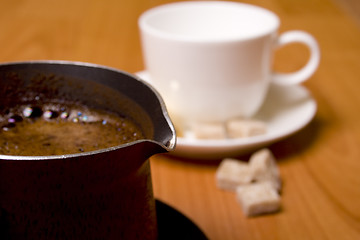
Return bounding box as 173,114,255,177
0,0,360,240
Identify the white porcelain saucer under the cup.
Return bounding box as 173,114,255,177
136,71,317,159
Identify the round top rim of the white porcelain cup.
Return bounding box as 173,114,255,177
138,1,280,43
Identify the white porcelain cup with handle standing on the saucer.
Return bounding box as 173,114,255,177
139,1,320,125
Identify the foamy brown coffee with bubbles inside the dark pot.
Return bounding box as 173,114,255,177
0,103,144,156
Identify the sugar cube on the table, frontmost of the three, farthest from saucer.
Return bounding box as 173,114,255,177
236,181,281,216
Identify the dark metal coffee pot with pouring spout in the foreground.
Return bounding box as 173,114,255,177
0,61,176,240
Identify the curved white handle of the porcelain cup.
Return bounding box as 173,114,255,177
272,30,320,85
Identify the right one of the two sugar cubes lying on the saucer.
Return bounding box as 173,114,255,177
226,119,266,138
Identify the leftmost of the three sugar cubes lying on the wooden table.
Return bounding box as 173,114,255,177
216,158,252,191
